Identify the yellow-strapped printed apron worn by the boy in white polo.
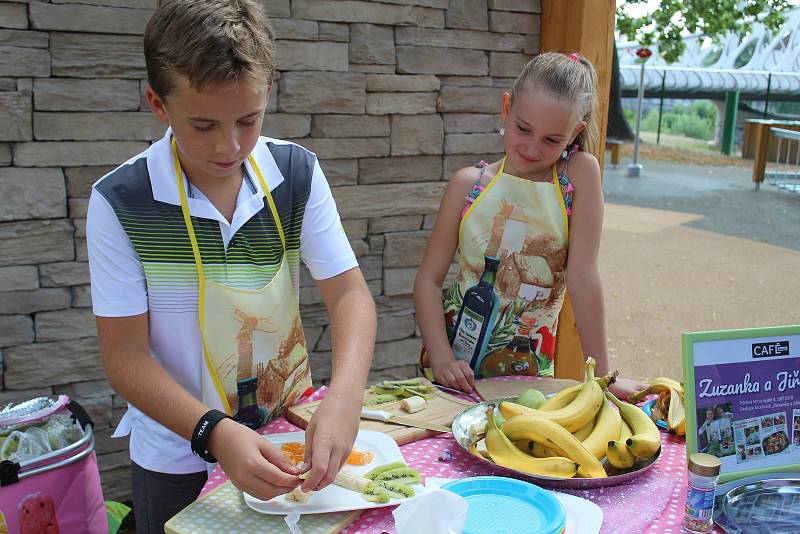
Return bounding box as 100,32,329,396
172,139,312,429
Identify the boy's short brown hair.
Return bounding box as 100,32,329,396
144,0,275,98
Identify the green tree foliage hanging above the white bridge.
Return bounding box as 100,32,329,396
617,0,792,63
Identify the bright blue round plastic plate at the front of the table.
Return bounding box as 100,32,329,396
442,476,567,534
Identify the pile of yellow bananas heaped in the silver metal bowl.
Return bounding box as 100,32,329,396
471,358,661,478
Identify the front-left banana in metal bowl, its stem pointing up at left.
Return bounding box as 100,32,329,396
486,404,578,478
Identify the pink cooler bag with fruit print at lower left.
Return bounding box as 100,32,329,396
0,395,108,534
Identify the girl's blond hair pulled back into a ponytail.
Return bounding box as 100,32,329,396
511,52,599,152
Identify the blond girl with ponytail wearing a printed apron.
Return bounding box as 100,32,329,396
414,53,643,397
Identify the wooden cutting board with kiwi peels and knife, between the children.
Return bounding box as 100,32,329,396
286,390,475,445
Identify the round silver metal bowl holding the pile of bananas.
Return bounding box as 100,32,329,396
452,397,661,489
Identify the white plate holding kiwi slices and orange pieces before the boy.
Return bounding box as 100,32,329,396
244,430,430,515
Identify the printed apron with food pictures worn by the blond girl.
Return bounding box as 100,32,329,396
432,158,569,377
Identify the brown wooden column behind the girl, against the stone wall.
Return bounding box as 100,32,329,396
539,0,616,380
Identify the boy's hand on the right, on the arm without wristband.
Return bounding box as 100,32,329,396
301,391,363,492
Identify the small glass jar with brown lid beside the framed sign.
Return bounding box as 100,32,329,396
682,453,722,532
